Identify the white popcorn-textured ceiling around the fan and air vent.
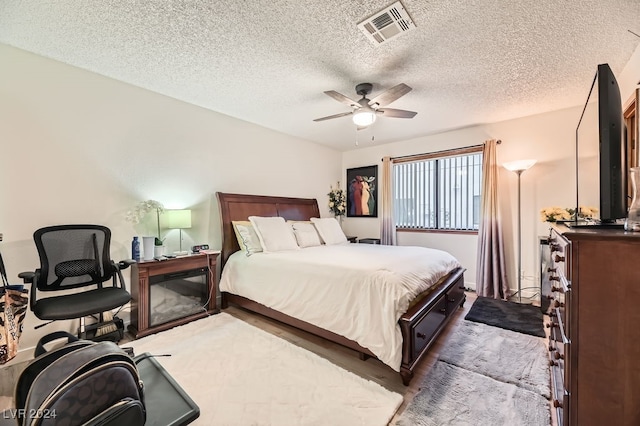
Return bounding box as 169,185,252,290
0,0,640,150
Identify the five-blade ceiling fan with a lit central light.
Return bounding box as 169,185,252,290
313,83,417,130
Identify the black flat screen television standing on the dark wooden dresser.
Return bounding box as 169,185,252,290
576,64,628,226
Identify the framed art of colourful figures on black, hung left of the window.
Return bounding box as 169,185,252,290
346,165,378,217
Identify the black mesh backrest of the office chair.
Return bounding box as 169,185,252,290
33,225,113,291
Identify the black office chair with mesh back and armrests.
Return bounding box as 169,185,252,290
18,225,135,340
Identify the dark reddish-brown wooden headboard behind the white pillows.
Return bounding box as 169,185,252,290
216,192,320,267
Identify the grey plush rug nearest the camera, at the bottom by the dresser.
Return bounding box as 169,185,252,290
396,361,551,426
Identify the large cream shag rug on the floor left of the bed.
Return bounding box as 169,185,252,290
123,313,403,426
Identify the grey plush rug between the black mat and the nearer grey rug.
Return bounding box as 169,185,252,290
439,321,551,398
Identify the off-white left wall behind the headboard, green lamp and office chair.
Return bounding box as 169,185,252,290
0,44,341,362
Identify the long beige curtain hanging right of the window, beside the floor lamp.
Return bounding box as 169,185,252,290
476,140,510,299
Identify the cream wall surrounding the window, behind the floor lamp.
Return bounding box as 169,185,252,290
342,46,640,295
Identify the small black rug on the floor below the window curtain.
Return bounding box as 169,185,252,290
464,297,545,337
